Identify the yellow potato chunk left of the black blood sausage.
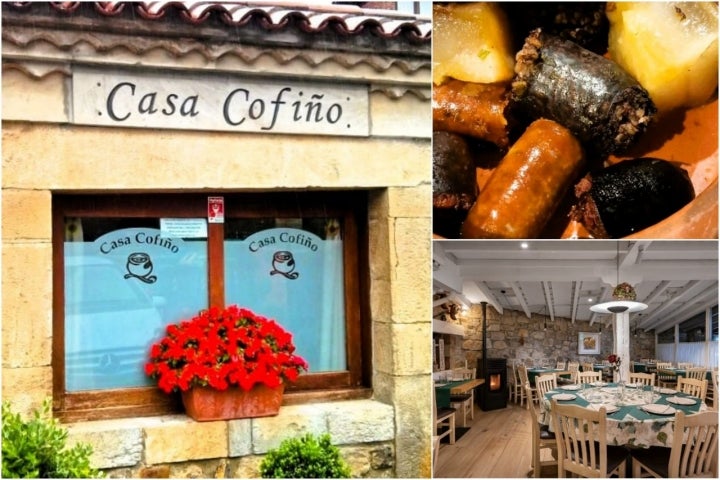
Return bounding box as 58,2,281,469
432,2,515,85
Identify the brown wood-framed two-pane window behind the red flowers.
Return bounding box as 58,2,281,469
53,192,371,420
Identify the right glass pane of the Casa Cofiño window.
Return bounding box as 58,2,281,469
225,218,347,373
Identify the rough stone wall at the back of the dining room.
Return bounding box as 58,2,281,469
454,305,655,366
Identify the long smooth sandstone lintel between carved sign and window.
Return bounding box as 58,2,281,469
3,122,430,190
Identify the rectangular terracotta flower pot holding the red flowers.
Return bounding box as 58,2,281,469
182,384,284,422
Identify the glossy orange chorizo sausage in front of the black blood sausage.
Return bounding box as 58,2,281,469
462,119,584,238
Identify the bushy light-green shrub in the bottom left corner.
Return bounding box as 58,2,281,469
2,399,102,478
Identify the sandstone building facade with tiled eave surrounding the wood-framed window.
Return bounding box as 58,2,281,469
2,2,432,478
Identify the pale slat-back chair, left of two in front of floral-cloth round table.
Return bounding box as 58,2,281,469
550,400,628,478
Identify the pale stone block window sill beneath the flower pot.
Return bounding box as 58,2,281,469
66,399,395,469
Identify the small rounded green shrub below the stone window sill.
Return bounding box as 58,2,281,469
260,433,350,478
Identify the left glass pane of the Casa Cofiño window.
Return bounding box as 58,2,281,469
64,218,208,391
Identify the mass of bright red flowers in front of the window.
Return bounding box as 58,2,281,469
145,305,308,393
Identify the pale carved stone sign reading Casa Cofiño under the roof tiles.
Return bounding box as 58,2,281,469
72,67,369,136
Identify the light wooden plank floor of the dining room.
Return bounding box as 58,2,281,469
434,403,557,478
